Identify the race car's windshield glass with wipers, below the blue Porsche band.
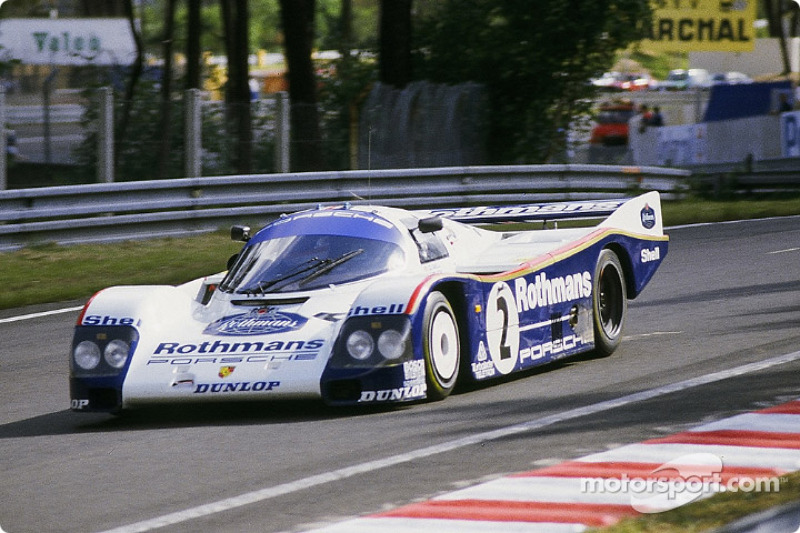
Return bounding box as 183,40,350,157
220,235,405,294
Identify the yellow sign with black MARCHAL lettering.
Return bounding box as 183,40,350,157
642,0,756,52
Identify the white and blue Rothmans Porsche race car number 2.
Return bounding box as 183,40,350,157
70,192,669,413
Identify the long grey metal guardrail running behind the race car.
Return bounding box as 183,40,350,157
0,165,690,250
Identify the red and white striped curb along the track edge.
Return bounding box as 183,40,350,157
309,399,800,533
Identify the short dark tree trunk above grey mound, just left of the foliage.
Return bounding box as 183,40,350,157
380,0,412,88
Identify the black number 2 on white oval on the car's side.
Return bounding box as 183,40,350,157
486,281,519,374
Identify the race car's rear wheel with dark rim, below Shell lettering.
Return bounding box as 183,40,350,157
592,248,628,357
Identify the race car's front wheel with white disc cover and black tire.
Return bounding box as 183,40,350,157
422,291,461,401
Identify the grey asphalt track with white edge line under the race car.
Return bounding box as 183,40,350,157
0,217,800,533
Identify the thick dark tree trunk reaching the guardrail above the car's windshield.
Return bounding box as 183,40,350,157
280,0,322,172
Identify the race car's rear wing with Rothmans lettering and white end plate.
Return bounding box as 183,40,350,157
414,192,663,235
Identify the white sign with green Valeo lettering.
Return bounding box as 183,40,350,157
0,18,136,66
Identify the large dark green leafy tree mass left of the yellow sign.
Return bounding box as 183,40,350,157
415,0,650,163
